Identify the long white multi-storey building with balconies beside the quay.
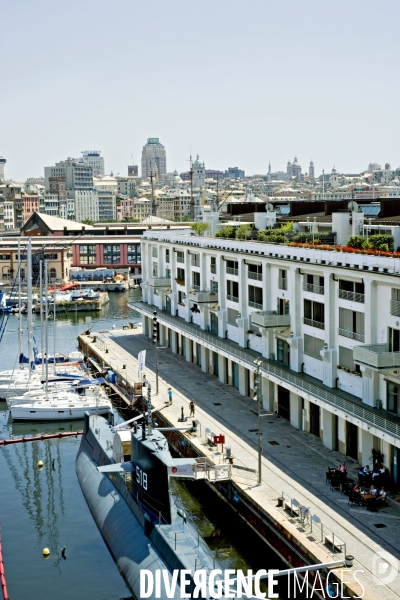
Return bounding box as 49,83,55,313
132,230,400,482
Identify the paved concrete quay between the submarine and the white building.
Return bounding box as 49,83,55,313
80,331,400,600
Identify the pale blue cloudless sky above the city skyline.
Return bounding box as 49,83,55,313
0,0,400,181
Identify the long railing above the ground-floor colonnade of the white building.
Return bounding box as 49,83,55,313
128,302,400,439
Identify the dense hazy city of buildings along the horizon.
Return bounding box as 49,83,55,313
0,138,400,231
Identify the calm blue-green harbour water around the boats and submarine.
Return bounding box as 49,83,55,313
0,291,288,600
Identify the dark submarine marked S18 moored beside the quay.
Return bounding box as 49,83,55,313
75,411,244,600
